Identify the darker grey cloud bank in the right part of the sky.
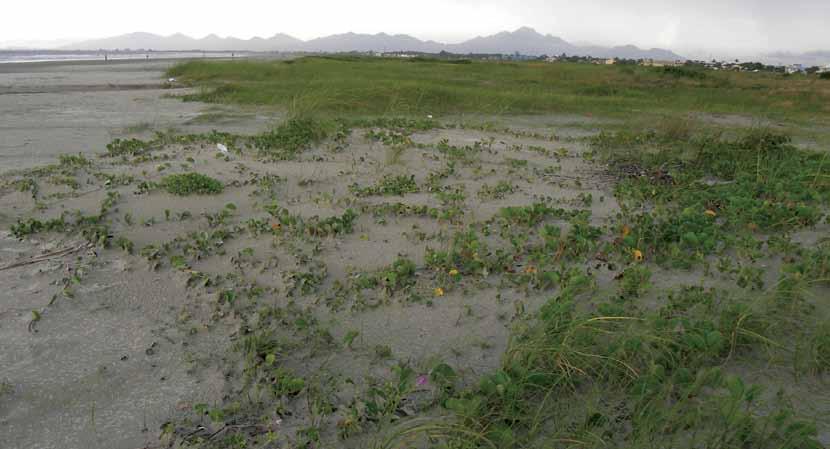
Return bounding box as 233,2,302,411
498,0,830,51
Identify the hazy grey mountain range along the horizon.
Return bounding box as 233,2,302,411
63,27,684,60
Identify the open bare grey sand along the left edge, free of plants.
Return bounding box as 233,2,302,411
0,60,279,449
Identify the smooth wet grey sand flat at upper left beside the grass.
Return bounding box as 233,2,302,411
0,60,280,172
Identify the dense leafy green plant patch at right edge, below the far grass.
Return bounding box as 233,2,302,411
593,129,830,262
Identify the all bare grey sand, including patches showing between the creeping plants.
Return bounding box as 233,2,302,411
0,57,614,449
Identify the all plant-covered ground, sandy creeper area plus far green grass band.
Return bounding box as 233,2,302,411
0,58,830,449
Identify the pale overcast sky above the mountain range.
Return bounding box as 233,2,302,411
0,0,830,54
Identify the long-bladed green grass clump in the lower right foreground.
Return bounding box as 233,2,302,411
424,278,826,449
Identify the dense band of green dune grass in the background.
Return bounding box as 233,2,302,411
168,57,830,119
